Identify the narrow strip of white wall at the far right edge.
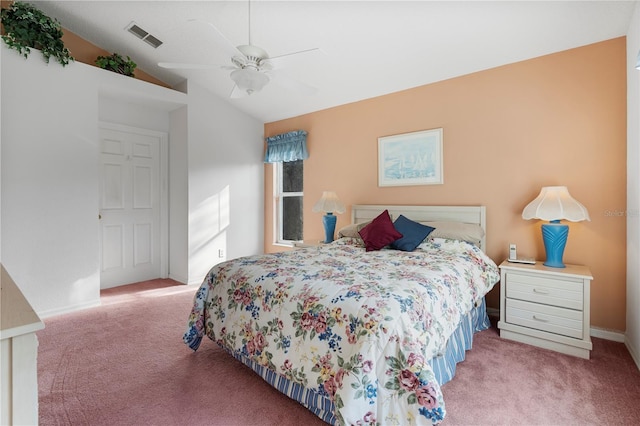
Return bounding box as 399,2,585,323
626,2,640,368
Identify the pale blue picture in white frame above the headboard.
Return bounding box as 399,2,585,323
378,129,444,186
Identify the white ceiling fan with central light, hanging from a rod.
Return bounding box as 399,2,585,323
158,1,321,98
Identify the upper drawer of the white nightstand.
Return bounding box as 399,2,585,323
506,272,584,311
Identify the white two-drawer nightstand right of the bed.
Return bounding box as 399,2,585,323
498,260,593,359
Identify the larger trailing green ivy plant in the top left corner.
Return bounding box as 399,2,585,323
0,1,74,67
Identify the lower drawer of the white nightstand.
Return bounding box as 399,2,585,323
505,299,583,339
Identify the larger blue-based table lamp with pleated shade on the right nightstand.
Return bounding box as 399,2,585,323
522,186,591,268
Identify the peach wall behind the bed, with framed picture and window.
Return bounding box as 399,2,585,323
265,37,626,331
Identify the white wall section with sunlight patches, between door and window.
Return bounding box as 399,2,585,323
188,82,264,284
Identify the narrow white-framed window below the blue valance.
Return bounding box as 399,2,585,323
273,160,303,244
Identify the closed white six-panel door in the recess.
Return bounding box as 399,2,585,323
100,128,162,288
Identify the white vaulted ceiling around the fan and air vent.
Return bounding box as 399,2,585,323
32,0,635,122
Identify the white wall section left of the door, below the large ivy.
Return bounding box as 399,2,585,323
1,49,100,316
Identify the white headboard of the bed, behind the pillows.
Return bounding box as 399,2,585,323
351,204,487,251
